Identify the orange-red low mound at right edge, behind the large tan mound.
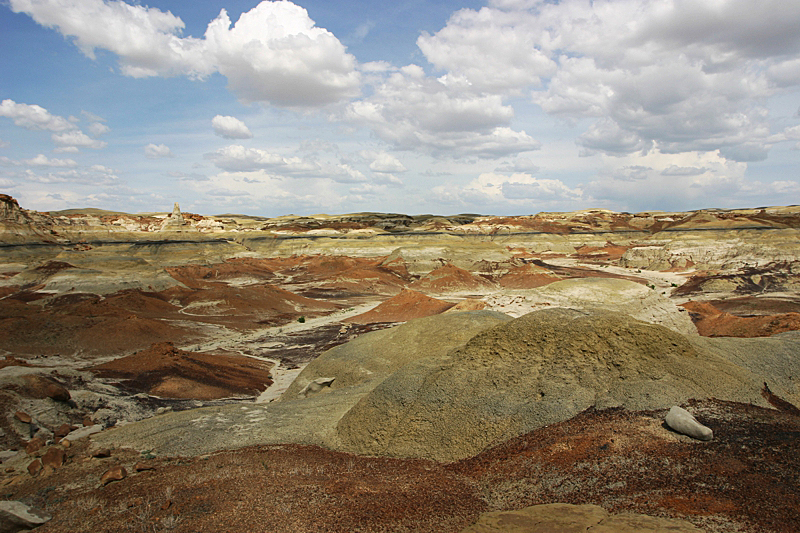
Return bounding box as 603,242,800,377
683,301,800,337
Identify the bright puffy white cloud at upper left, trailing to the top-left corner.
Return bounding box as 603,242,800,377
9,0,361,107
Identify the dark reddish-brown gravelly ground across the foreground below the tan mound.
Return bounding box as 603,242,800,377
1,400,800,533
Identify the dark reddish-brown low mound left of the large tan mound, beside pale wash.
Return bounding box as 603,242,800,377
89,342,272,400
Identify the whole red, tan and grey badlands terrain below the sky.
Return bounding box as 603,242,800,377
0,195,800,533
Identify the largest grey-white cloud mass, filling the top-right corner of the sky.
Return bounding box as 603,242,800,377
418,0,800,161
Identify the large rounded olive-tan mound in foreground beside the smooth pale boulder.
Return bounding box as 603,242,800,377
338,309,776,461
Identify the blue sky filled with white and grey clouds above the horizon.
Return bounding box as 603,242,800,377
0,0,800,216
